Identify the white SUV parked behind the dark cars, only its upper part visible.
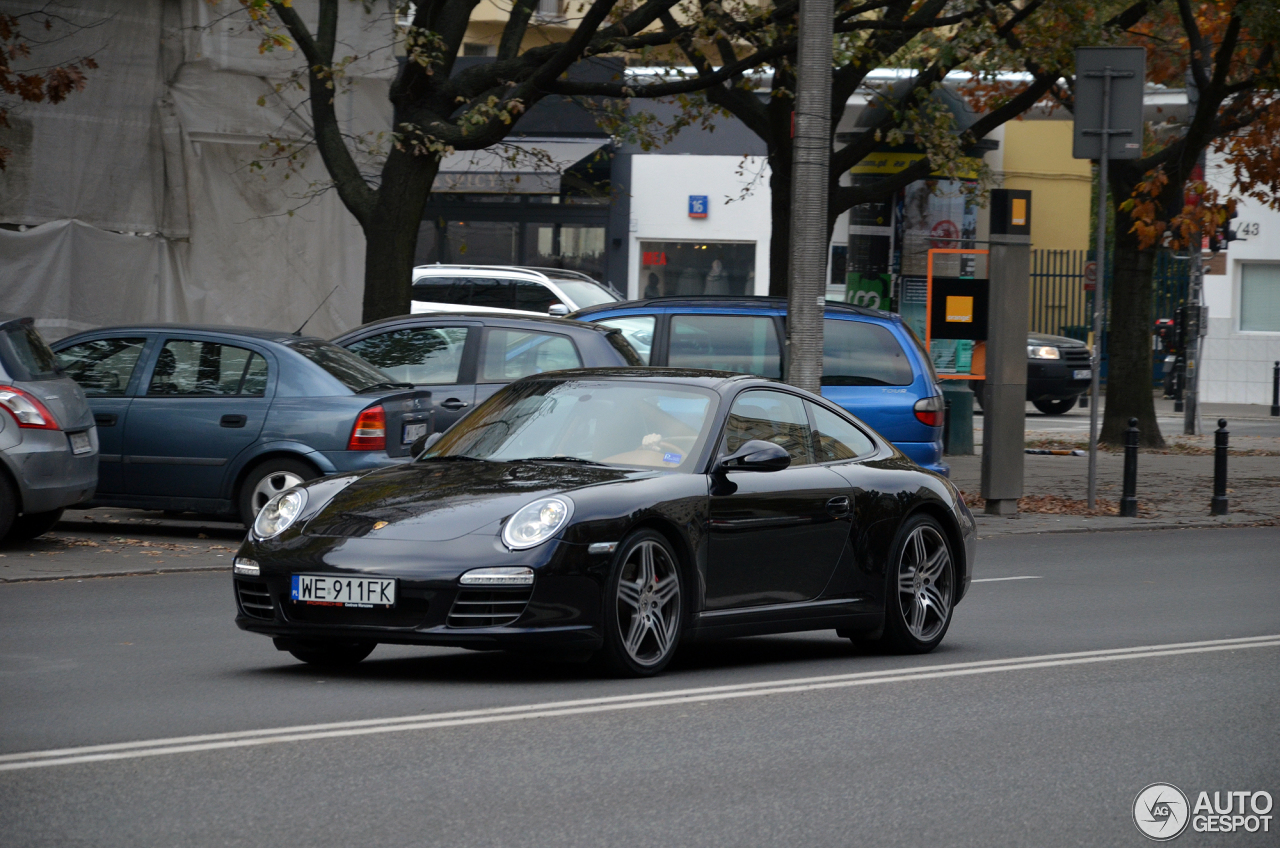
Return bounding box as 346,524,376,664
412,265,622,315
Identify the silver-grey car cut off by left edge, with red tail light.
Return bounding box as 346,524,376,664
0,313,97,541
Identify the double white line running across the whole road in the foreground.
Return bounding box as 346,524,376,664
0,634,1280,771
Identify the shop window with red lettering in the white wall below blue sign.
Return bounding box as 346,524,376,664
640,241,755,297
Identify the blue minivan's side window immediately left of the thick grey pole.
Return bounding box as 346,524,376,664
667,315,782,378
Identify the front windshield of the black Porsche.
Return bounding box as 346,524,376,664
424,380,716,471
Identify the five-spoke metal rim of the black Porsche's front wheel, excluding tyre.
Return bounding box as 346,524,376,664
617,539,680,666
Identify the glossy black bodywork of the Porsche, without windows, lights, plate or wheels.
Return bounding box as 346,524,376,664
236,369,974,649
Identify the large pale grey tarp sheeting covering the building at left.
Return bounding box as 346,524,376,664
0,0,394,338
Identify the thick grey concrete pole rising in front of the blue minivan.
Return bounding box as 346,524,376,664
787,0,835,392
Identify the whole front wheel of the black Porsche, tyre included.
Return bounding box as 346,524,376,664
602,530,684,678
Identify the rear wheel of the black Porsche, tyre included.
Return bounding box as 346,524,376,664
883,514,956,653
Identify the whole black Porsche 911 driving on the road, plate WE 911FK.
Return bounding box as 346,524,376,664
233,368,974,675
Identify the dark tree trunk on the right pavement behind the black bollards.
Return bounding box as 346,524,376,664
1098,188,1165,447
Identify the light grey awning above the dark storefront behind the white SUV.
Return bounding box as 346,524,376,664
431,138,608,195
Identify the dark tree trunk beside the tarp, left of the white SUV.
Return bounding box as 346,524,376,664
361,149,440,323
